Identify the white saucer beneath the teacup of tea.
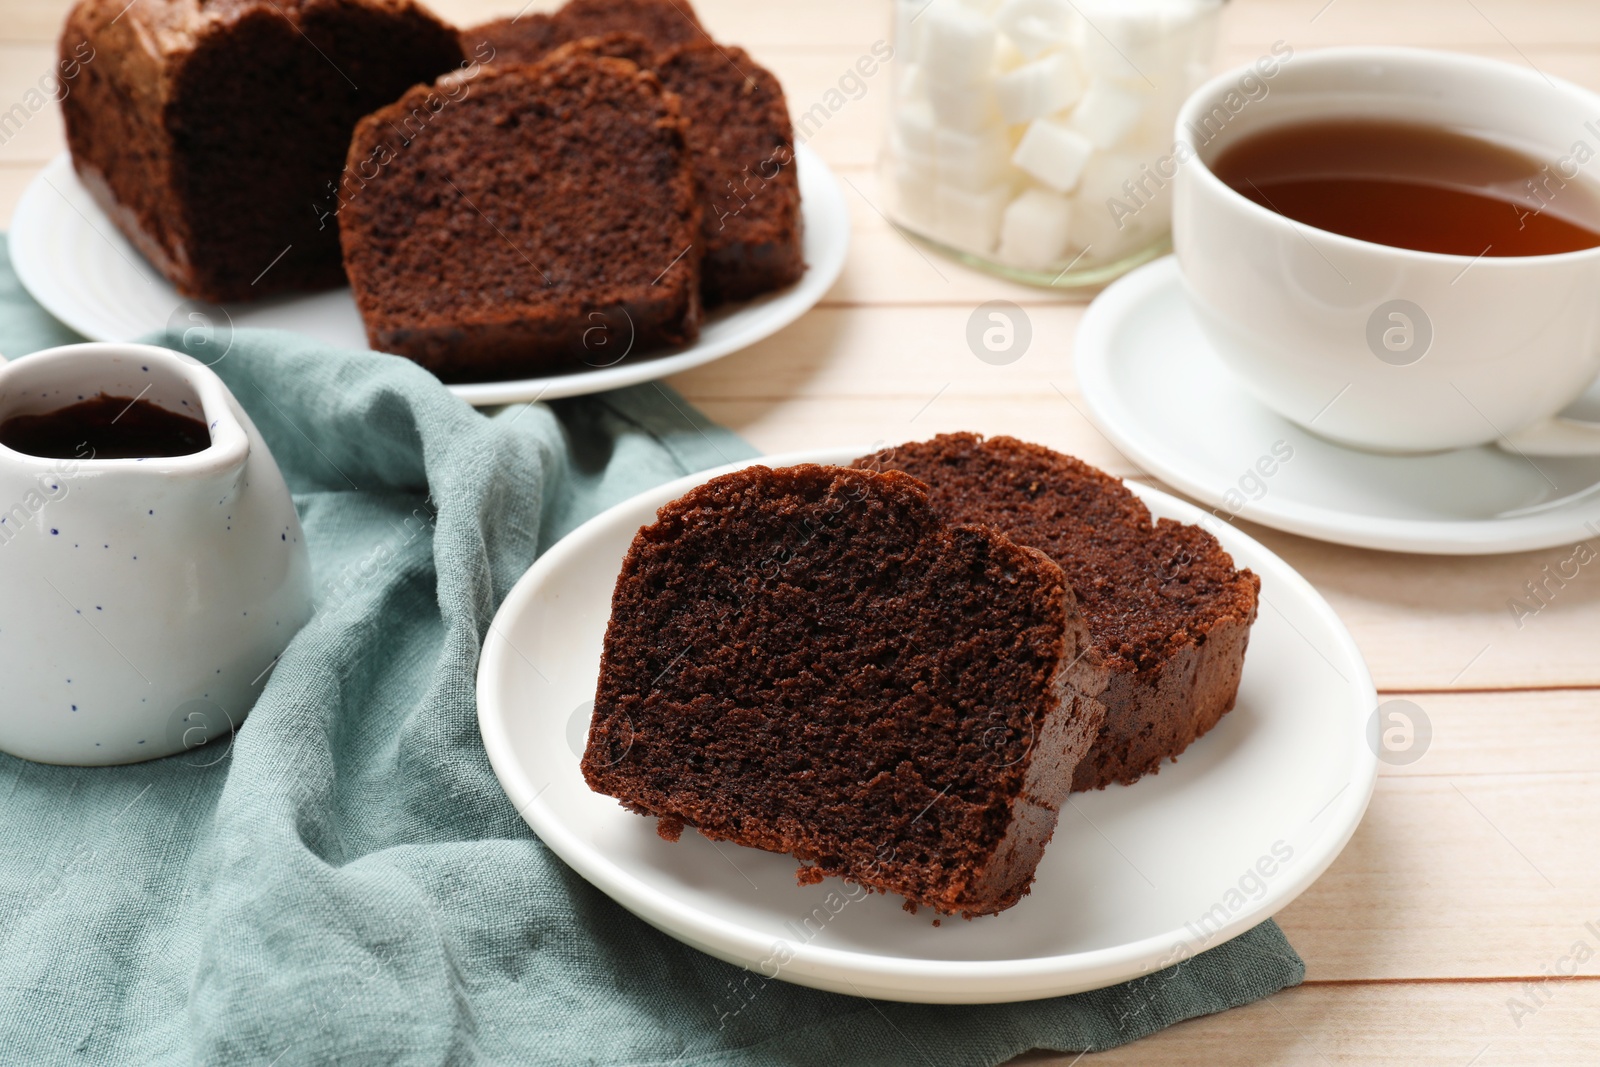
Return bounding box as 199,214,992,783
1077,256,1600,555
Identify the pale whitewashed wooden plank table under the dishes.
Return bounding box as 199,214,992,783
0,0,1600,1067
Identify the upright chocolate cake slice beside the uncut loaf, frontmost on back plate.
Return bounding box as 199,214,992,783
339,54,701,381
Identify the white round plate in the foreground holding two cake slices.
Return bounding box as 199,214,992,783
478,448,1378,1003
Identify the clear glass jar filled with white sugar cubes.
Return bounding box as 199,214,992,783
880,0,1222,288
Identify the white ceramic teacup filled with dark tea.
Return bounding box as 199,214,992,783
1173,48,1600,454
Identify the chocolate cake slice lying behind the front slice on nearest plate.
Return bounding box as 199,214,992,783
856,434,1261,790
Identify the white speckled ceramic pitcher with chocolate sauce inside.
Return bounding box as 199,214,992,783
0,344,312,765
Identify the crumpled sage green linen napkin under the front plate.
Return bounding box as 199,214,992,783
0,235,1304,1067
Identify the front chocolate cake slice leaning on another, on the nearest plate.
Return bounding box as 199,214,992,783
582,466,1106,915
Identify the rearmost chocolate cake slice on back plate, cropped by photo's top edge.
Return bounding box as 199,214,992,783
461,0,710,64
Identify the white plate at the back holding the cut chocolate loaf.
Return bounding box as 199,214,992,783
11,146,850,405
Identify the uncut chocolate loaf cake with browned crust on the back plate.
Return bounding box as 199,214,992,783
61,0,462,301
